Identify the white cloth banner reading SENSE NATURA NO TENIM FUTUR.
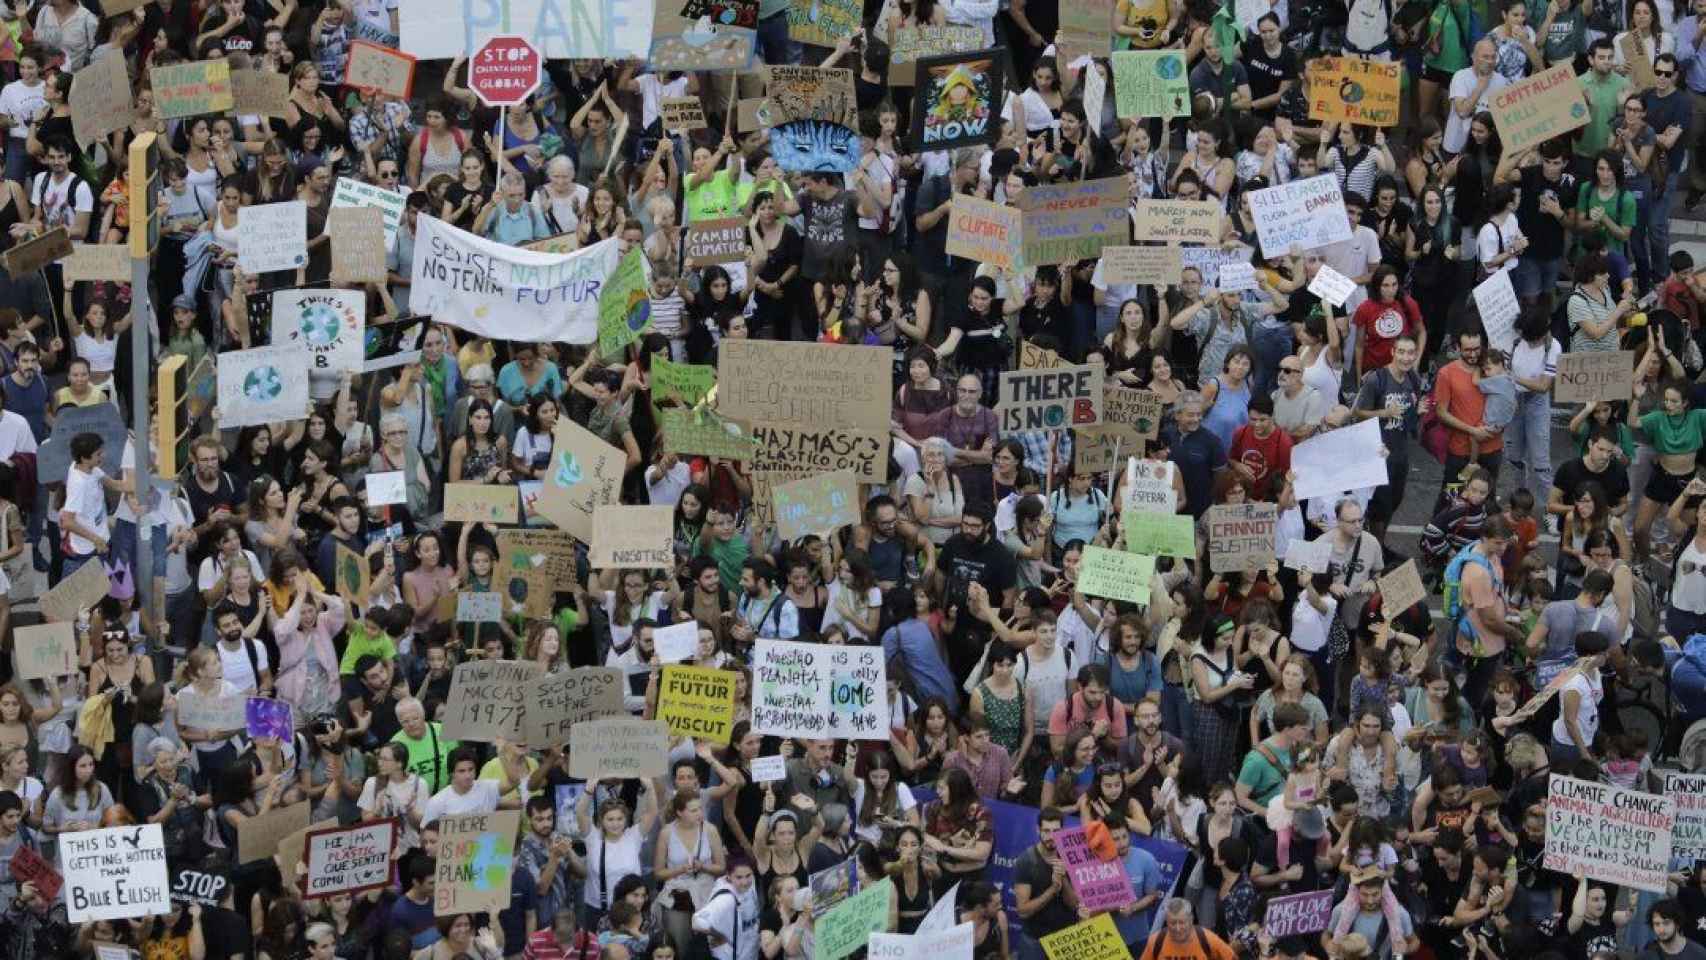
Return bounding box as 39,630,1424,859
409,215,621,343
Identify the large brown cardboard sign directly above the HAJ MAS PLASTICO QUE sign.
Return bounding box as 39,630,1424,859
717,335,893,429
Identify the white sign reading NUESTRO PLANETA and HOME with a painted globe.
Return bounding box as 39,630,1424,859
752,639,889,740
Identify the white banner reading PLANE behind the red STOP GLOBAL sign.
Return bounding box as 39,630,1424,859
397,0,653,60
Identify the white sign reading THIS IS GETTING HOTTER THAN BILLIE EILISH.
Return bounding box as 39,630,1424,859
60,824,172,924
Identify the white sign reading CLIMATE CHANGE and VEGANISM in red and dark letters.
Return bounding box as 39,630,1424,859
1544,774,1677,895
